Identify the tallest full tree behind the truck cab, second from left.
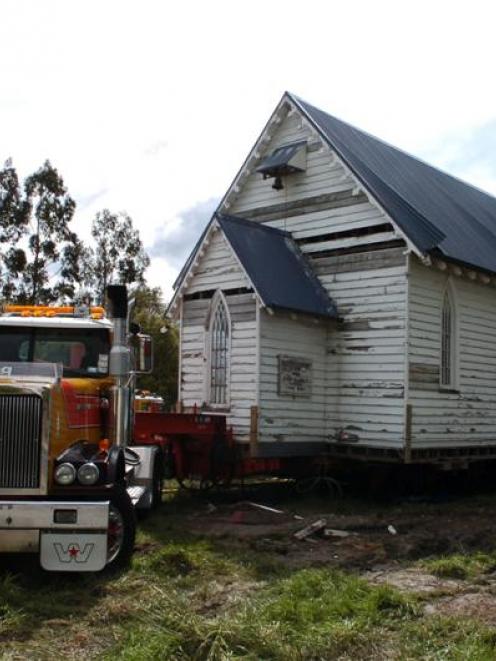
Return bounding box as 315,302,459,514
5,161,76,305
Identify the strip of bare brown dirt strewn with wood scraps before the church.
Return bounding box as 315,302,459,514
187,503,496,571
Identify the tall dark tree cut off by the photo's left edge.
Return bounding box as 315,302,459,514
0,159,29,298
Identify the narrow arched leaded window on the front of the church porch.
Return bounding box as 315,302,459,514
209,294,230,405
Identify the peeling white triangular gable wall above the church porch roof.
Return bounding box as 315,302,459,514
221,100,404,256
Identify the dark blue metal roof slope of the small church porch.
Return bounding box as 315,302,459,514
214,213,337,318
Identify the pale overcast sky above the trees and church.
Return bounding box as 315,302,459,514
0,0,496,298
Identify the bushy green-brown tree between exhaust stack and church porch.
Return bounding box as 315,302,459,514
133,287,179,409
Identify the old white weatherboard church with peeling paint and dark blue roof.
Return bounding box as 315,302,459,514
170,93,496,466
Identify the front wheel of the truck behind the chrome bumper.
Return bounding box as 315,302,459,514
106,490,136,569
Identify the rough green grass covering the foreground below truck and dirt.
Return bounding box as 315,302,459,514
0,488,496,661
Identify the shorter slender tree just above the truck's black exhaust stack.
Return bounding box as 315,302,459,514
91,209,150,304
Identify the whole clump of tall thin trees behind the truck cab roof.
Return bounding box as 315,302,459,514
0,160,150,304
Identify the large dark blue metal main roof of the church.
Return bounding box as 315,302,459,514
288,94,496,272
